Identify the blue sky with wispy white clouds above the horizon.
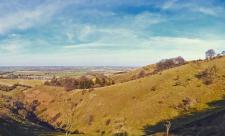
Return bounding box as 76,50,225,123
0,0,225,66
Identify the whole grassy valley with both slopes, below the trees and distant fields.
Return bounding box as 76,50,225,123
0,57,225,136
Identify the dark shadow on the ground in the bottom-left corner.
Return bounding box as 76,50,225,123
0,118,62,136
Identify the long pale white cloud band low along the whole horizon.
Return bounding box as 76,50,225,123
0,35,225,65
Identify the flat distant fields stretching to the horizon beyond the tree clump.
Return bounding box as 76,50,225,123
0,67,132,80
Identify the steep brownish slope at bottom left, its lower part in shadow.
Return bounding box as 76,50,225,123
0,90,62,136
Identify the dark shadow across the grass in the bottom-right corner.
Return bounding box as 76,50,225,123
143,98,225,136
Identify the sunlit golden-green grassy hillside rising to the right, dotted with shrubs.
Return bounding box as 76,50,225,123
12,57,225,135
